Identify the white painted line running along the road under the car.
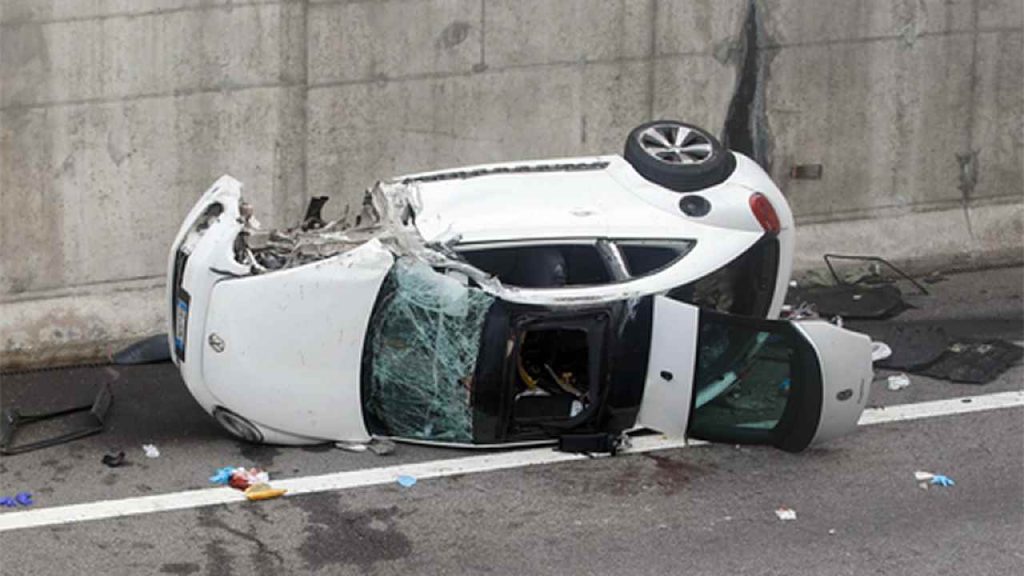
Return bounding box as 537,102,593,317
0,390,1024,532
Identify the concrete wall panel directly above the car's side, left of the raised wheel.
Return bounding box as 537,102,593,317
308,58,648,204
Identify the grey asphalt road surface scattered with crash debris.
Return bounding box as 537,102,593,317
0,269,1024,575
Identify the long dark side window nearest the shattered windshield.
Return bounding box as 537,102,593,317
459,244,612,288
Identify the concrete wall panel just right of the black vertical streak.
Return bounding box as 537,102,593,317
766,35,972,219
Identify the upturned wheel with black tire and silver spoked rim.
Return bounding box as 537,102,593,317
623,120,736,192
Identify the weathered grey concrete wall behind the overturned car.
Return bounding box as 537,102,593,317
0,0,1024,367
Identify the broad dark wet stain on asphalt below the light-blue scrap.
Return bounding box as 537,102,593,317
289,494,413,571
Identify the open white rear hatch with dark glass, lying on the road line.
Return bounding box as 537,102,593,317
637,296,872,452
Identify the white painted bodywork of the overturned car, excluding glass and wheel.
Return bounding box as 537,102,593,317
168,146,871,449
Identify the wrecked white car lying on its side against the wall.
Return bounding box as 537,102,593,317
168,121,871,451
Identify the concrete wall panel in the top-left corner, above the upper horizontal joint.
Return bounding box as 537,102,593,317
0,4,303,108
